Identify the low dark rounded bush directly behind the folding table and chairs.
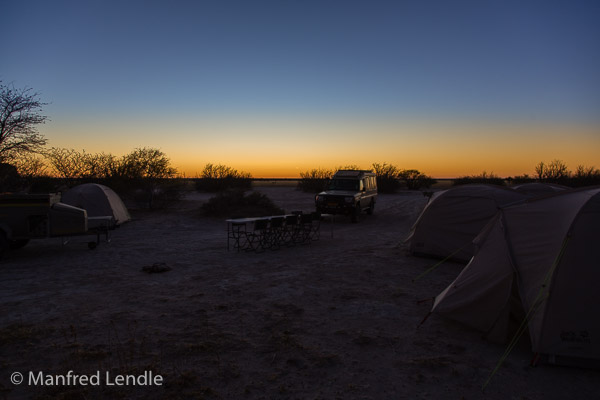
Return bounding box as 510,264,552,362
202,189,285,218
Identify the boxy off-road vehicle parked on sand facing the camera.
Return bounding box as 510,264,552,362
315,170,377,222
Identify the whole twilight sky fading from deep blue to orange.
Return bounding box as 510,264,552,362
0,0,600,178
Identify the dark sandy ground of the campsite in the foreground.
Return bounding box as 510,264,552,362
0,186,600,399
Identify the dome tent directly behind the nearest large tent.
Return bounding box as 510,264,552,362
406,185,527,262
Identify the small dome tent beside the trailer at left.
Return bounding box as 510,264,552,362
61,183,131,225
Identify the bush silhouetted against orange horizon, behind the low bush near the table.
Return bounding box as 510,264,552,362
195,164,252,192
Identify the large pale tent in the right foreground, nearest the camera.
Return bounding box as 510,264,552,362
432,188,600,363
